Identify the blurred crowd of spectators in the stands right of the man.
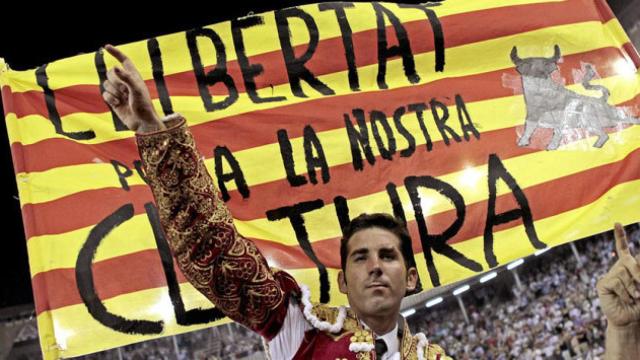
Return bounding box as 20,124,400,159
409,229,640,360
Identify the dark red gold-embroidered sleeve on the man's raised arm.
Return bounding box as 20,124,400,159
136,115,298,339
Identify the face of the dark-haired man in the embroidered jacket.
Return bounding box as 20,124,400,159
338,227,418,316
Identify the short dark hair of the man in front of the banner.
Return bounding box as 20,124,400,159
340,213,416,271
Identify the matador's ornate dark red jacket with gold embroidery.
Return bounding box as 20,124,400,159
136,114,445,360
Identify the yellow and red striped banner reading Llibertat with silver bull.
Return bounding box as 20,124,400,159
0,0,640,359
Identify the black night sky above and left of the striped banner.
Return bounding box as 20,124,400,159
0,0,626,308
